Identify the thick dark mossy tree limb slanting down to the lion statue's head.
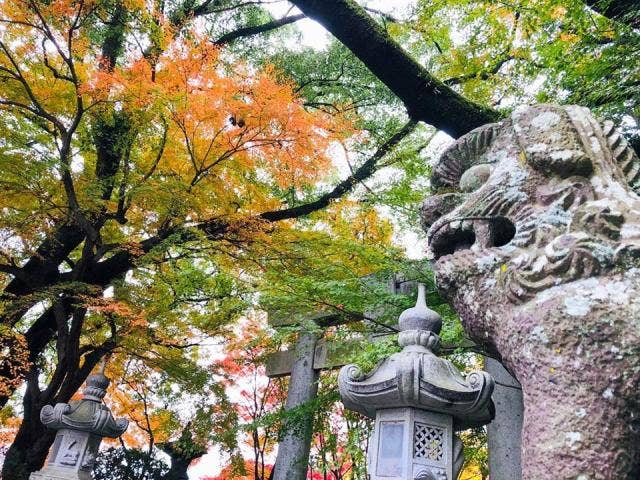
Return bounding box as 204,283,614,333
292,0,500,138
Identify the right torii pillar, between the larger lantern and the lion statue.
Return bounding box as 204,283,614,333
484,357,524,480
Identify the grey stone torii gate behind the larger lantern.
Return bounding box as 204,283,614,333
266,278,523,480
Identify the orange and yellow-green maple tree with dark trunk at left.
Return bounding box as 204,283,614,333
0,0,418,478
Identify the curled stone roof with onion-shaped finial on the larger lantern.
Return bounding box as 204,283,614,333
338,285,495,430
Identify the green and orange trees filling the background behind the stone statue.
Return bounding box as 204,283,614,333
0,0,640,480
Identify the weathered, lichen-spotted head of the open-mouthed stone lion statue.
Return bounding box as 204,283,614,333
421,105,640,324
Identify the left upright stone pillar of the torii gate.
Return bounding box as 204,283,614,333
273,330,319,480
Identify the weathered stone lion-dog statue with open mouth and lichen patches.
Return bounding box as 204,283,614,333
421,105,640,480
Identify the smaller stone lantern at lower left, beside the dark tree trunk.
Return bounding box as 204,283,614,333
29,367,129,480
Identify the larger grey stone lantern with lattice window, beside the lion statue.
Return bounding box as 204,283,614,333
338,285,494,480
